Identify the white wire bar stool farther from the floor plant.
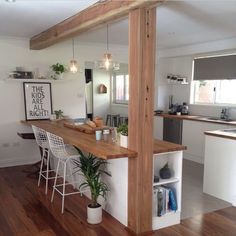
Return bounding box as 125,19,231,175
32,125,55,194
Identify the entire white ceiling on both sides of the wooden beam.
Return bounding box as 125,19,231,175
0,0,236,49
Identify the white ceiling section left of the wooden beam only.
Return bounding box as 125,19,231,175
0,0,98,38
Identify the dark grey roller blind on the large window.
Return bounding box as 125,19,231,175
193,55,236,80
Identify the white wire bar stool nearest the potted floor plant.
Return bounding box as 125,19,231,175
47,132,88,214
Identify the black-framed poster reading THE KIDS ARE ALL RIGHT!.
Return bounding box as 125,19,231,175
23,82,52,120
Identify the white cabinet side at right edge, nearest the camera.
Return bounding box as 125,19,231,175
203,135,236,206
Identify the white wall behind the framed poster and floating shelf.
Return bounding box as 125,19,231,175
0,37,130,167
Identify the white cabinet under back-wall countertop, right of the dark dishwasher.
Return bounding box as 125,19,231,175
182,120,229,164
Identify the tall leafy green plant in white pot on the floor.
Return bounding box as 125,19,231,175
74,148,111,224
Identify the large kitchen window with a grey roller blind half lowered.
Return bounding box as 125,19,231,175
192,55,236,105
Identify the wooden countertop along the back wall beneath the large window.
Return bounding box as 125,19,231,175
155,113,236,126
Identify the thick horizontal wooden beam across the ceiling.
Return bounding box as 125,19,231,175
30,0,163,50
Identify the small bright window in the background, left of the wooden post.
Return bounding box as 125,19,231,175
112,74,129,104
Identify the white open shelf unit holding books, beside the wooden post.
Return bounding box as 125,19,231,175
152,151,183,230
